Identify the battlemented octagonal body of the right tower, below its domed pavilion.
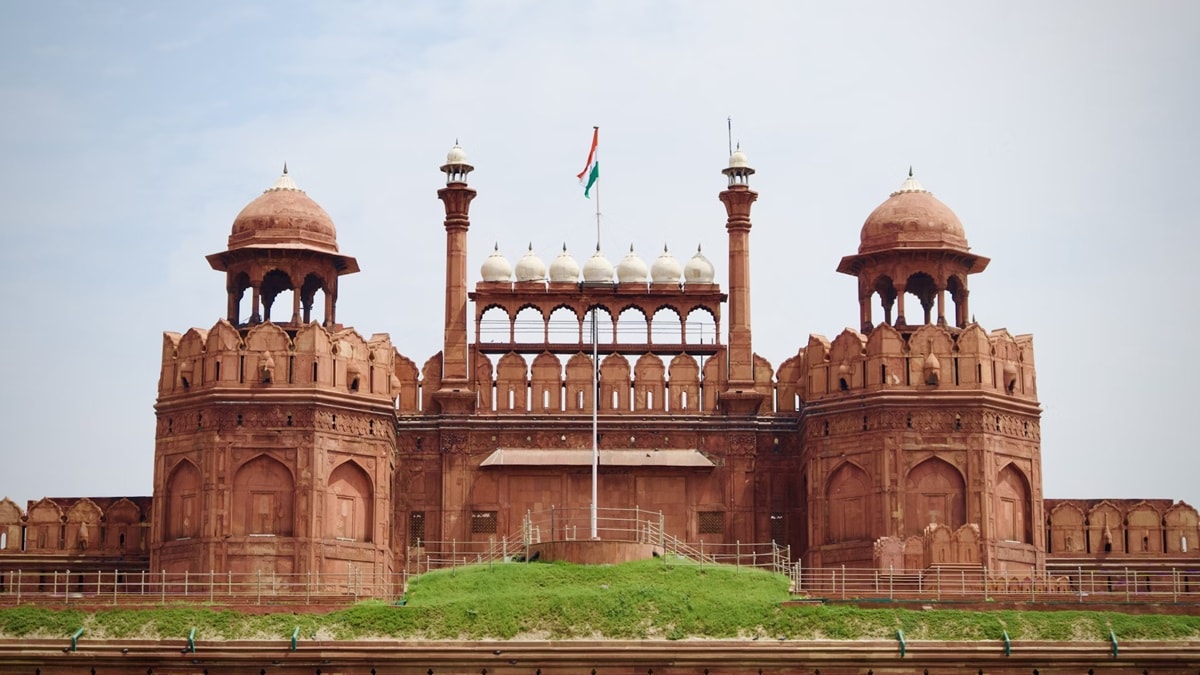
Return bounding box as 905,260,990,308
792,323,1044,573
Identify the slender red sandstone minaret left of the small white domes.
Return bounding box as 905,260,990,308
433,142,475,414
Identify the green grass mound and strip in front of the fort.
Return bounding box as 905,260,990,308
0,560,1200,641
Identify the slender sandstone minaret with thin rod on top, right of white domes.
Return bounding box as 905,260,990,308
721,147,762,414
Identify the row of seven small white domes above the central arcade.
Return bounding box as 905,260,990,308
479,244,716,283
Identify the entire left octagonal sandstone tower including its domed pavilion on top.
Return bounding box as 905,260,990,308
150,168,395,592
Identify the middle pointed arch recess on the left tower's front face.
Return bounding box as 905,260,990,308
233,455,295,537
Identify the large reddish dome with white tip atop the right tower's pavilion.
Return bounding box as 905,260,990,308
858,172,968,253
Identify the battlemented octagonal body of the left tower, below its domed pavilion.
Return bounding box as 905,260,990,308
151,321,402,584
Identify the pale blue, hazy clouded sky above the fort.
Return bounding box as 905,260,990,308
0,0,1200,506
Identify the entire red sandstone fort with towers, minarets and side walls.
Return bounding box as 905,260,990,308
0,145,1200,584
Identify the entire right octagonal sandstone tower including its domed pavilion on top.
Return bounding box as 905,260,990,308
802,171,1045,577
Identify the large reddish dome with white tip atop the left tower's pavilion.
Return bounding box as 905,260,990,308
229,166,337,252
